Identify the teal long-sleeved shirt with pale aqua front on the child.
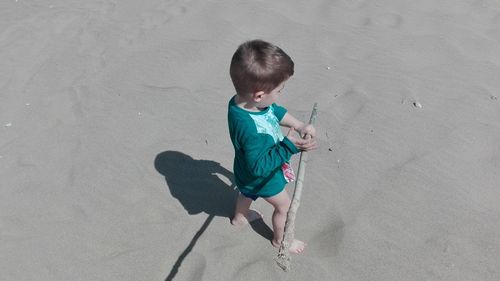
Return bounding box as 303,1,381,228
228,97,299,197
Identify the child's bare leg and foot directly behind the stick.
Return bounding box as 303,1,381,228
264,190,306,254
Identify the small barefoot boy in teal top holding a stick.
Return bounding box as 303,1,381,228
228,40,316,253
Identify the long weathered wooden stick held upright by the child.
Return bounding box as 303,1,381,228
275,103,318,271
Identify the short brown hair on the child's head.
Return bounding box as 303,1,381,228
229,40,294,95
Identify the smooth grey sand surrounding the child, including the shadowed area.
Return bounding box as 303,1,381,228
0,0,500,281
